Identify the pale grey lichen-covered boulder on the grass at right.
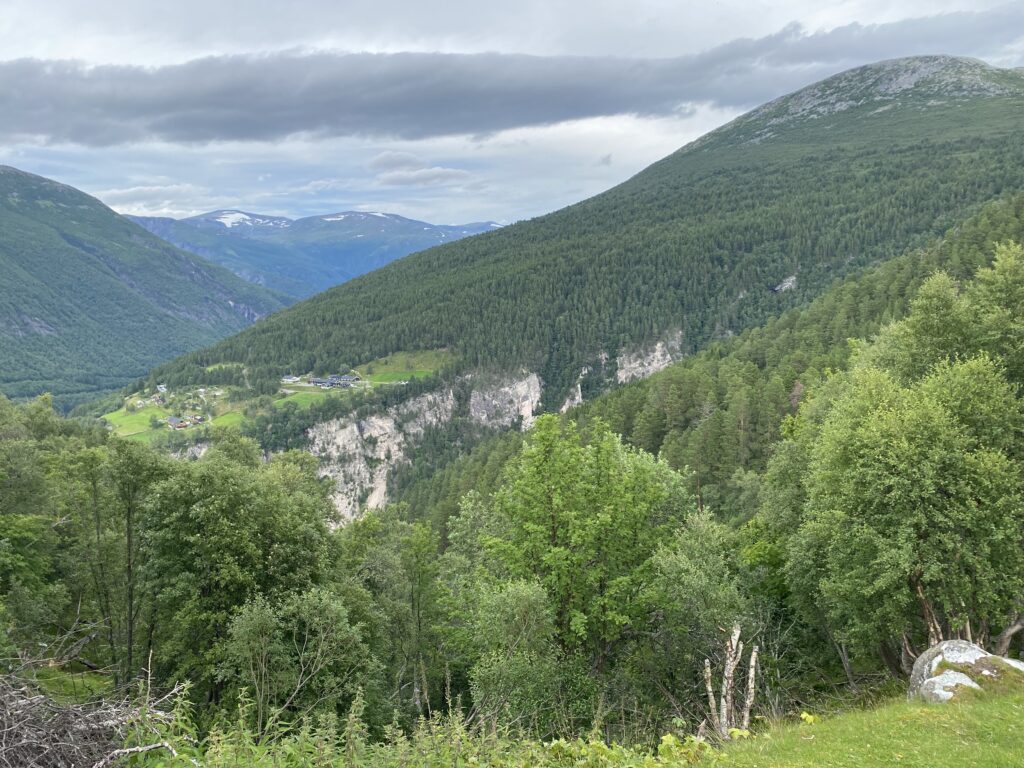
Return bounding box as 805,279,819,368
907,640,1024,701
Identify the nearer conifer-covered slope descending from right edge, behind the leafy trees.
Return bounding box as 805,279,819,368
390,194,1024,527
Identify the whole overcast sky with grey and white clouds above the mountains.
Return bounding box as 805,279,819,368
0,0,1024,223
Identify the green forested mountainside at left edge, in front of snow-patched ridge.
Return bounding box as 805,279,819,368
0,166,290,404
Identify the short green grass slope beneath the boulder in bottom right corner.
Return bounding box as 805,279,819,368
723,690,1024,768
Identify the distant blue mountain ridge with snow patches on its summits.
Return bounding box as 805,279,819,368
128,209,500,298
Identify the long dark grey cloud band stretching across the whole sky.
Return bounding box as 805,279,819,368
0,2,1024,146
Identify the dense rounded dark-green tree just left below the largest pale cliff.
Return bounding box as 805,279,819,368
144,438,330,702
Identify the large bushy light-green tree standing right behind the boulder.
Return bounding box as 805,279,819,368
790,362,1024,648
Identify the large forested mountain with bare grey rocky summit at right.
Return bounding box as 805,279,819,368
151,56,1024,409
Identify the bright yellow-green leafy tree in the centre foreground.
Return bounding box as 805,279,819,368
493,417,692,673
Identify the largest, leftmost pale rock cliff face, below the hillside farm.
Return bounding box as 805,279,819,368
308,389,455,519
